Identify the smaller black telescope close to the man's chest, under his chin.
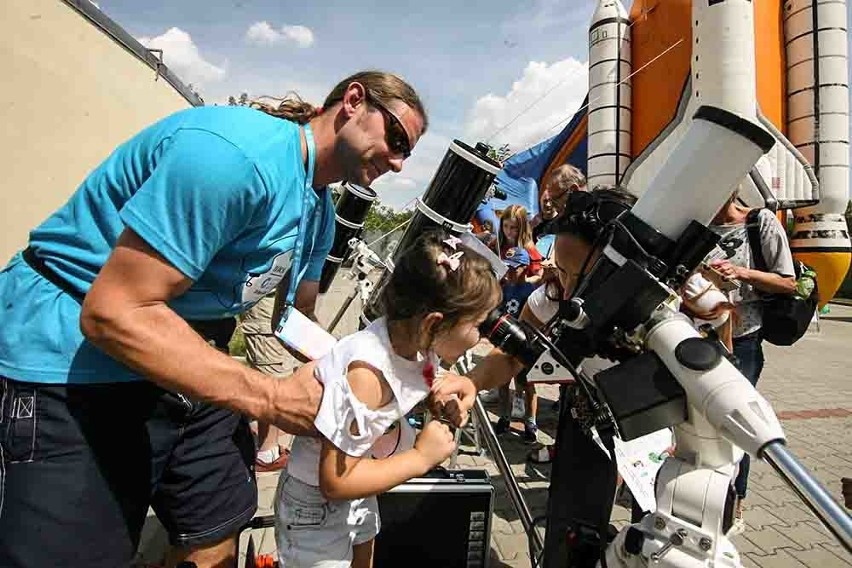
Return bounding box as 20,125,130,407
319,182,376,294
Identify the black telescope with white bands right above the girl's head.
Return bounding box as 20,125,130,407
364,140,500,320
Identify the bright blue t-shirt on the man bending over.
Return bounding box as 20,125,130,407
0,107,334,383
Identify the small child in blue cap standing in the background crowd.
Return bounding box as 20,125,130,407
494,246,538,442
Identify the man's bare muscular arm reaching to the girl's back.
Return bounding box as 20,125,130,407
80,229,322,433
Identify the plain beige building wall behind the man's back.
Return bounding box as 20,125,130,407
0,0,200,266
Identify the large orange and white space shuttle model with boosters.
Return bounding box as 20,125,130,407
576,0,850,303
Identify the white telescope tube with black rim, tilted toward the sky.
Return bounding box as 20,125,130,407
632,106,775,241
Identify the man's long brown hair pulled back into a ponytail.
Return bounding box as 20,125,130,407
249,71,429,133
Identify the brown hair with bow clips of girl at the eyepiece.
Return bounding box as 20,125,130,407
382,230,502,333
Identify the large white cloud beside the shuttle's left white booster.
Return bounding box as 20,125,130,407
465,57,588,152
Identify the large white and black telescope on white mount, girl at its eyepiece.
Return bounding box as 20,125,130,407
472,106,852,568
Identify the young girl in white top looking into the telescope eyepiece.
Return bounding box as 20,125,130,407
275,232,501,568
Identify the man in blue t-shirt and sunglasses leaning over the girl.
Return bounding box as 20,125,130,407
0,71,426,568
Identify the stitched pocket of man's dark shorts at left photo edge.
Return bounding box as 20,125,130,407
0,379,38,463
